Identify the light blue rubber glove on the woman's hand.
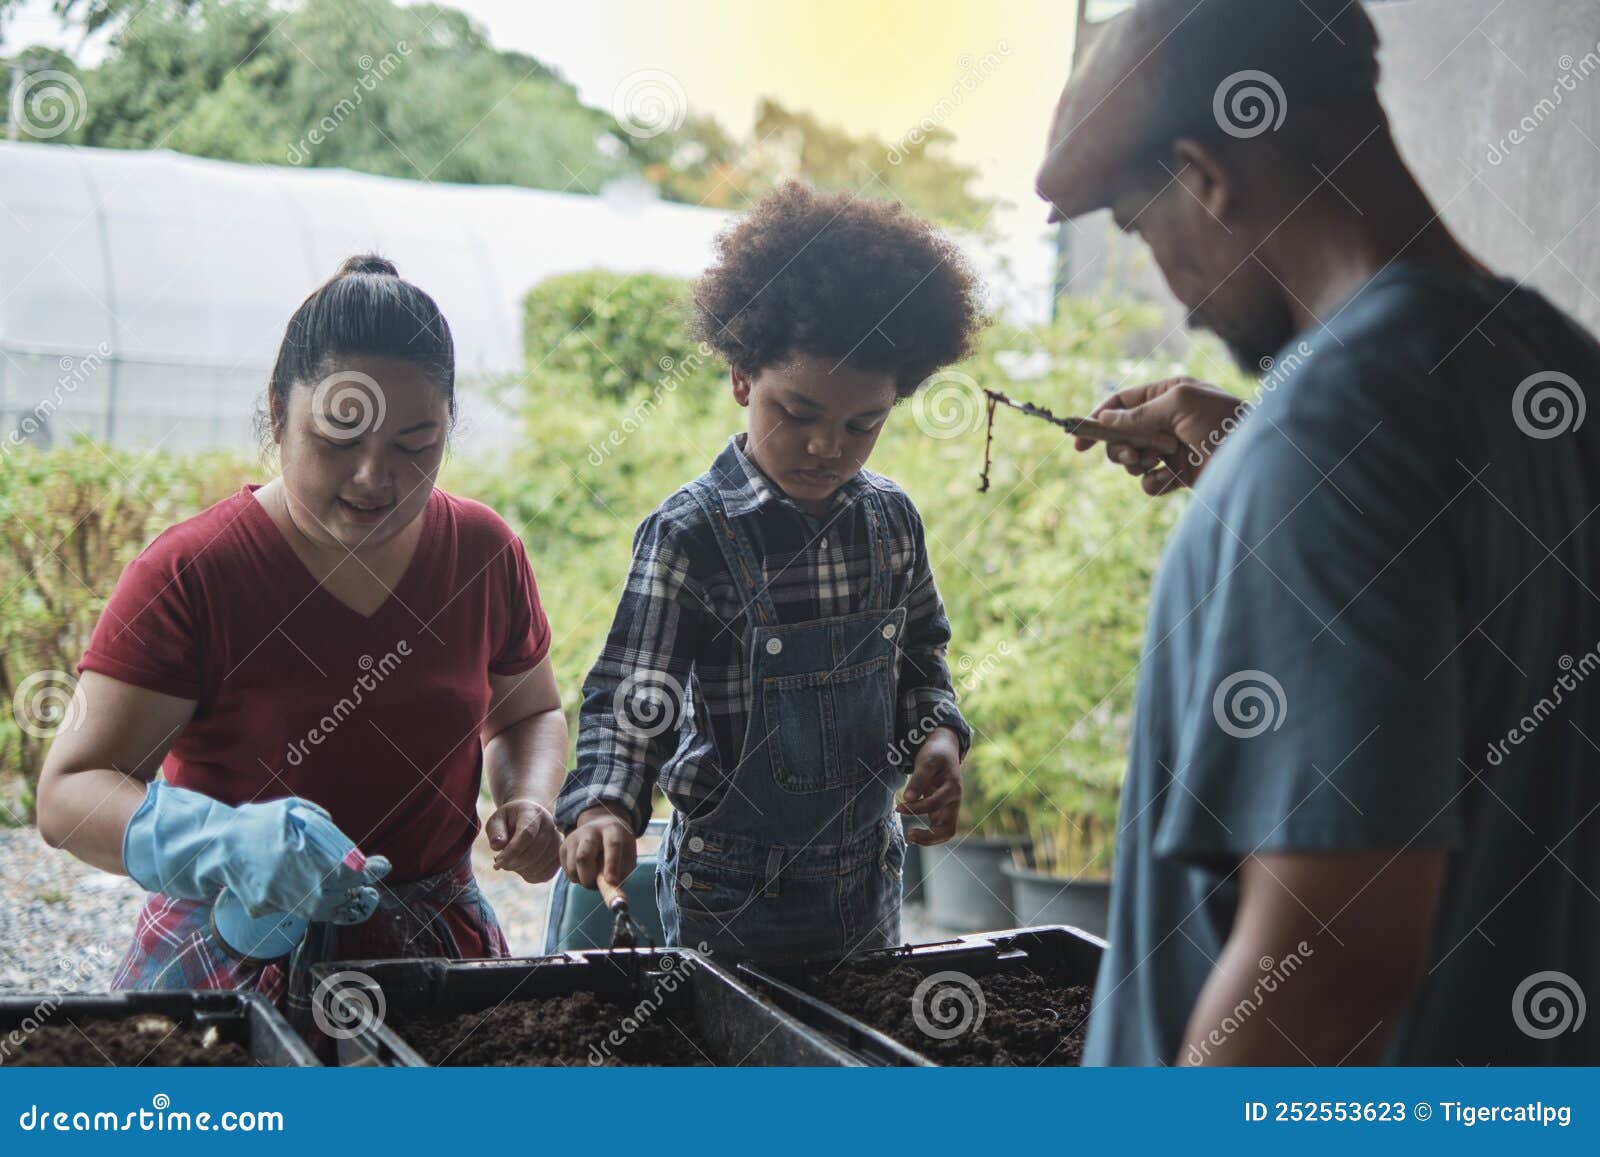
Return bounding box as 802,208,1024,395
122,781,390,923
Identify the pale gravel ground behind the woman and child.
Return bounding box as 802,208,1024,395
0,811,949,992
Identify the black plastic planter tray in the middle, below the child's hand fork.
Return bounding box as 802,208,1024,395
312,949,861,1067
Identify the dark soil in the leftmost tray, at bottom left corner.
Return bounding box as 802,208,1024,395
0,1013,254,1067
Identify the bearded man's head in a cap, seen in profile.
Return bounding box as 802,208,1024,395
1038,0,1408,370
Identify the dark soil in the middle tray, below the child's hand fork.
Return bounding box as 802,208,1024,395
394,992,712,1066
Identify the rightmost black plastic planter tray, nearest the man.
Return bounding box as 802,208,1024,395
738,925,1106,1067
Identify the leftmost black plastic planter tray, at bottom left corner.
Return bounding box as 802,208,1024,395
0,989,322,1067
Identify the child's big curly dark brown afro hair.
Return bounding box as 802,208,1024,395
693,181,984,398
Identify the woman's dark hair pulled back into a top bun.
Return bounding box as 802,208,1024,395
267,253,456,430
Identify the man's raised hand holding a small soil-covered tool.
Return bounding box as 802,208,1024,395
1072,378,1250,494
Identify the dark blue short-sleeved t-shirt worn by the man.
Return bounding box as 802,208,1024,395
1085,264,1600,1064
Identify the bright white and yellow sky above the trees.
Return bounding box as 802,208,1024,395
6,0,1075,211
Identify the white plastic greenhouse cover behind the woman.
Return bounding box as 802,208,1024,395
0,142,728,450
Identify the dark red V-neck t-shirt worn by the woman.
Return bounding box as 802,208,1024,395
78,486,550,882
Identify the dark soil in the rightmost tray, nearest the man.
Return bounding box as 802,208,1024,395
806,965,1093,1066
